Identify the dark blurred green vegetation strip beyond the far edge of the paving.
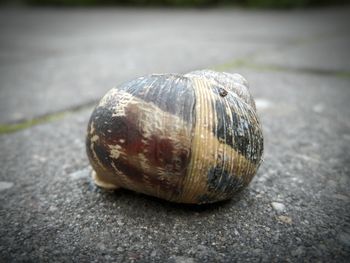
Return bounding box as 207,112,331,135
0,0,348,8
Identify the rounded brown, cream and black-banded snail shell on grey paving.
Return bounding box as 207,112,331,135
86,70,263,204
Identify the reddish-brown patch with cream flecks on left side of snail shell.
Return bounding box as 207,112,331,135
88,92,191,202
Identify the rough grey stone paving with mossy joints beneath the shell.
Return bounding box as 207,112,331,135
0,8,350,263
